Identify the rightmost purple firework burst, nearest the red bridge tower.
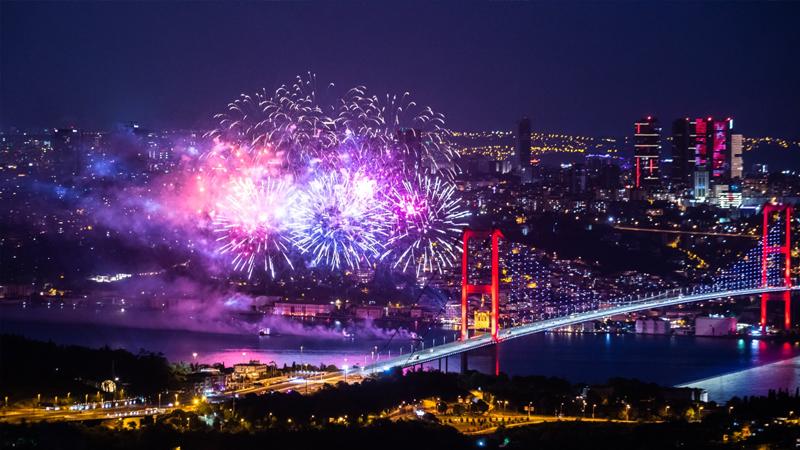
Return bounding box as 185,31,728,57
382,175,469,276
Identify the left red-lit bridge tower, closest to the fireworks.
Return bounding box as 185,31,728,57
461,228,504,341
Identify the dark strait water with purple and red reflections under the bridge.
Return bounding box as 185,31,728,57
0,306,800,401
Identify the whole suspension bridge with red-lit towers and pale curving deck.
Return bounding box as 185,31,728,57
362,204,800,373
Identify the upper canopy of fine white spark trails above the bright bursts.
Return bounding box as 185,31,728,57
209,74,458,179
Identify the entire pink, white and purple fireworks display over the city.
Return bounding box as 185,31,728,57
191,75,468,278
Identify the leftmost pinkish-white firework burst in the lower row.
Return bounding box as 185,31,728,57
213,178,292,278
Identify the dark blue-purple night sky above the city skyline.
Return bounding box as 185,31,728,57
0,1,800,137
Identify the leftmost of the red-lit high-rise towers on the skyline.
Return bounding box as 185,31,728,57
633,116,661,188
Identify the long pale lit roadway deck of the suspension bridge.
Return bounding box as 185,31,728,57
362,286,800,373
